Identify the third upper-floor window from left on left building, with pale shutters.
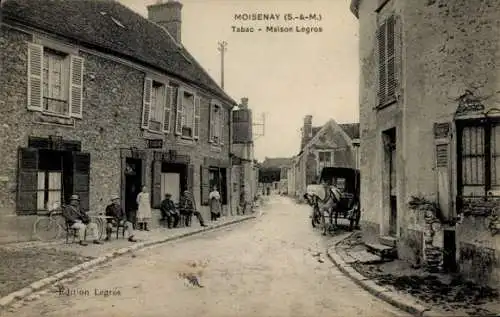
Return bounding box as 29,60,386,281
175,89,201,139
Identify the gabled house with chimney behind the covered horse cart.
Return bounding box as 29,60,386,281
289,116,359,196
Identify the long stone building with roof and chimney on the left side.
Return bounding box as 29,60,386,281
0,0,236,241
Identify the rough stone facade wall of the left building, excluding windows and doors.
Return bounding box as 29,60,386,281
0,25,231,241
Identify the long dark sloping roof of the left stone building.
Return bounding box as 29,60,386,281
2,0,237,105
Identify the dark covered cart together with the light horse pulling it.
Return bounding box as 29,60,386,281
304,167,361,234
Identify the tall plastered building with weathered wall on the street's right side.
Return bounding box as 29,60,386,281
351,0,500,285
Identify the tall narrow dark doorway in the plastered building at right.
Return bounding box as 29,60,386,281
383,128,398,237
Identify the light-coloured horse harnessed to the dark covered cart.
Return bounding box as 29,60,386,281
304,185,342,235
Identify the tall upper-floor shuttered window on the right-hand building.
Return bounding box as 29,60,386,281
377,16,400,106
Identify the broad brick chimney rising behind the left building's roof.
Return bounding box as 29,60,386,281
148,0,182,44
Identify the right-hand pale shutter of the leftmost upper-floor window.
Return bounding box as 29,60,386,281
69,55,83,118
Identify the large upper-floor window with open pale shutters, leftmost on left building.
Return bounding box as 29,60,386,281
28,43,83,118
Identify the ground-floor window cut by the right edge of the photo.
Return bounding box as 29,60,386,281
458,121,500,196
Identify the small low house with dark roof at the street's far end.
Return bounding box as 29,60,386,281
259,157,292,194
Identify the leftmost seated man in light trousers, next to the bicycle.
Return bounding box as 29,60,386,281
63,195,102,246
